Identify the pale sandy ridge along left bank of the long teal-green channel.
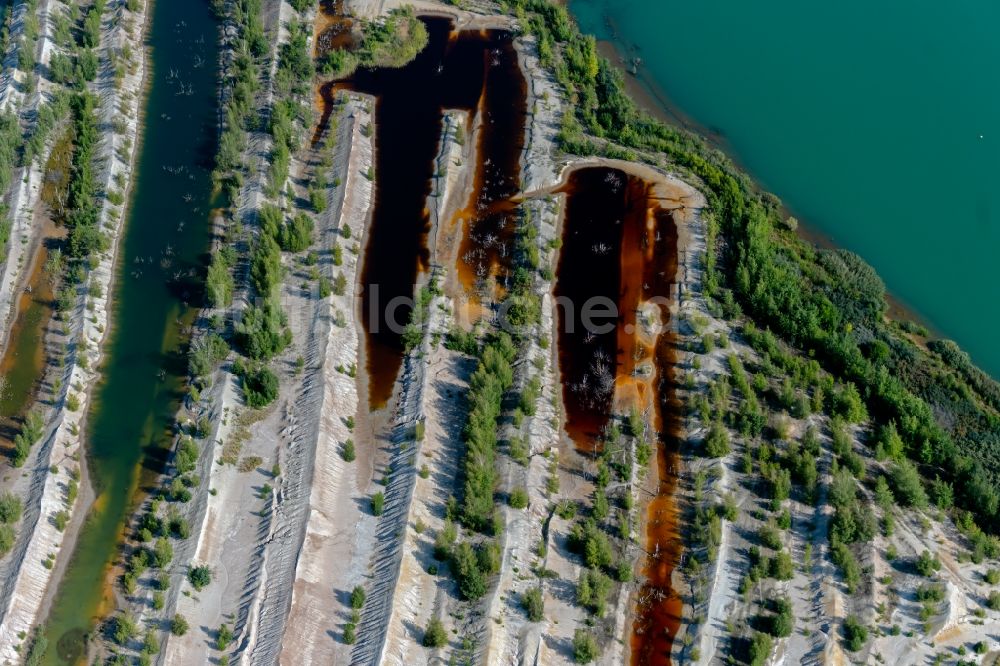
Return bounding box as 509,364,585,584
0,3,147,659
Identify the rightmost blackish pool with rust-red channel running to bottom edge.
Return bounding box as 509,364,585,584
555,167,682,666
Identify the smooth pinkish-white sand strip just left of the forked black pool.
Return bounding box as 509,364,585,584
280,94,375,664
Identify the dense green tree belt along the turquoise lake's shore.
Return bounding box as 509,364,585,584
506,0,1000,530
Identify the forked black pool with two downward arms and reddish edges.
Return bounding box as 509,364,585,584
317,15,527,409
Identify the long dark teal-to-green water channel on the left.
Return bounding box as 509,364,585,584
45,0,218,664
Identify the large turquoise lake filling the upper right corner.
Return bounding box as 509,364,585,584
569,0,1000,377
